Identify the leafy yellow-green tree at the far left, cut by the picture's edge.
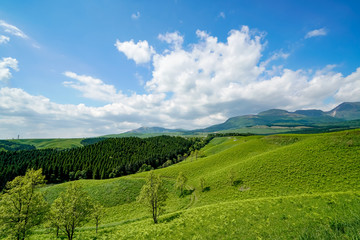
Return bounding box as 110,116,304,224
0,169,47,240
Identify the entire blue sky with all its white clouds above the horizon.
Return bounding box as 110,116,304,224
0,0,360,139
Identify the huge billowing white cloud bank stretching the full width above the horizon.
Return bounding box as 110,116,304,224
0,26,360,137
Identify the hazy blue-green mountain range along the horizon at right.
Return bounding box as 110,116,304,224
116,102,360,136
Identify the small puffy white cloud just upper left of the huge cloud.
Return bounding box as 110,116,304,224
115,39,155,64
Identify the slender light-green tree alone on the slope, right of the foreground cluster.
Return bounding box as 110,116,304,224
137,171,167,223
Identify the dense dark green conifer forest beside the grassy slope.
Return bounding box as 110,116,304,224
0,136,210,189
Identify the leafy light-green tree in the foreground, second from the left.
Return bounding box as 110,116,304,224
50,182,93,240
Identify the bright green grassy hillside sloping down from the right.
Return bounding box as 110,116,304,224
4,130,360,239
